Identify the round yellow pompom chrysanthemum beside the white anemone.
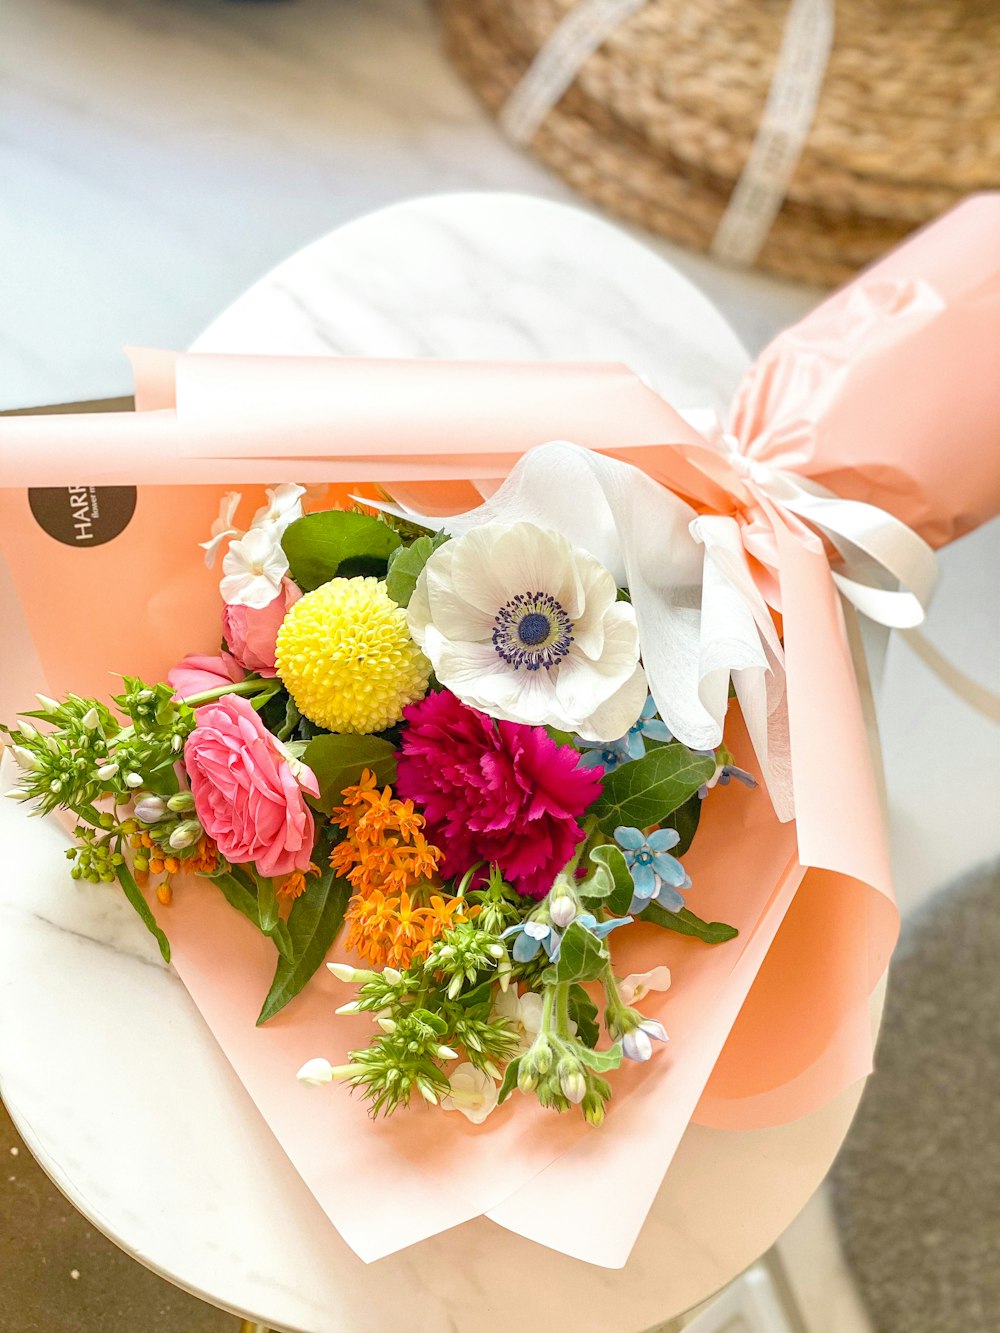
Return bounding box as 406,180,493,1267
275,579,431,736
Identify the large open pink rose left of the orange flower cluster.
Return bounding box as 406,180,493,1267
184,694,319,877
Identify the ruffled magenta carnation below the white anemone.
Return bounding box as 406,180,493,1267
396,690,601,898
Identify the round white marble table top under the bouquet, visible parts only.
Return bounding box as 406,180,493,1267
0,197,997,1333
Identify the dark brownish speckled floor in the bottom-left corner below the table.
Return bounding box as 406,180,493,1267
0,1102,239,1333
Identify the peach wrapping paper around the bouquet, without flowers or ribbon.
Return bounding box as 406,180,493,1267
0,196,1000,1266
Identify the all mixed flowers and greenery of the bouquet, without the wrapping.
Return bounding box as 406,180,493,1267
7,484,756,1124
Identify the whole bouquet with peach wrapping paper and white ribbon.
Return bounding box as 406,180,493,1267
0,197,1000,1265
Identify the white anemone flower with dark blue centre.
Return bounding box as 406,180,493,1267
407,523,647,741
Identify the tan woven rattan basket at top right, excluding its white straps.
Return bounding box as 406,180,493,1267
437,0,1000,283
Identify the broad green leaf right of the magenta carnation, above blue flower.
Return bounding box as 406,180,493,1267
593,744,715,833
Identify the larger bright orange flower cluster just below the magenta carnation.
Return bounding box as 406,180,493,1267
329,769,464,969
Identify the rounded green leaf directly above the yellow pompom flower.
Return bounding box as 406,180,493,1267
281,509,400,592
